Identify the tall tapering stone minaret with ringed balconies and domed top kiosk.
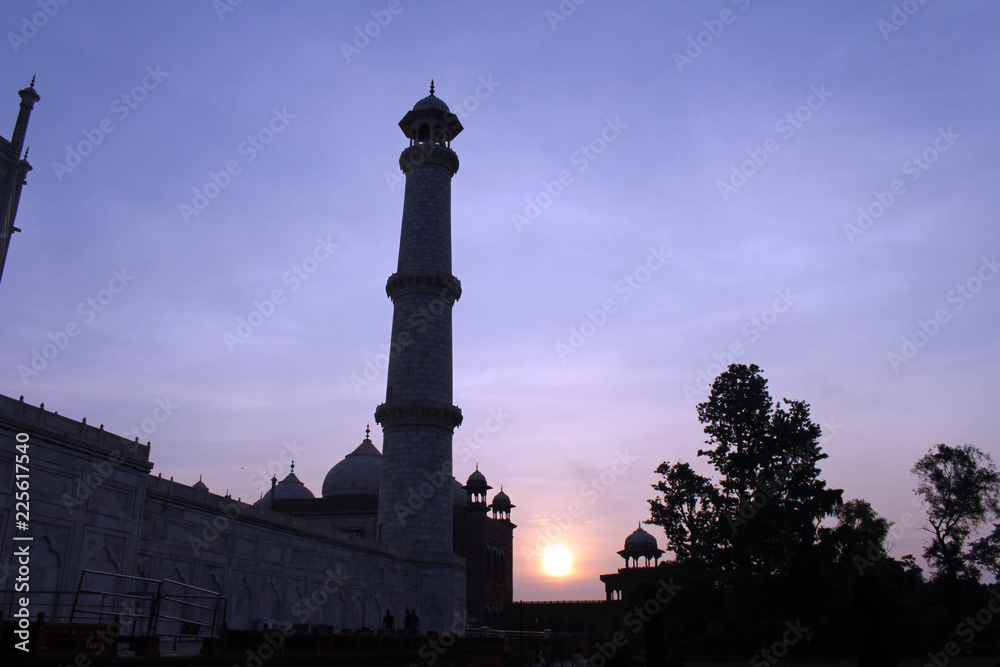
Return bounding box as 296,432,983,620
375,81,462,563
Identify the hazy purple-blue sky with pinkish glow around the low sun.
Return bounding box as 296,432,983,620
0,0,1000,600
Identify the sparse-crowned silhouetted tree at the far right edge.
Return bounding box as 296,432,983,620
911,444,1000,585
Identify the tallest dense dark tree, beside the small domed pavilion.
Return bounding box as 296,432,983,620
648,364,842,574
